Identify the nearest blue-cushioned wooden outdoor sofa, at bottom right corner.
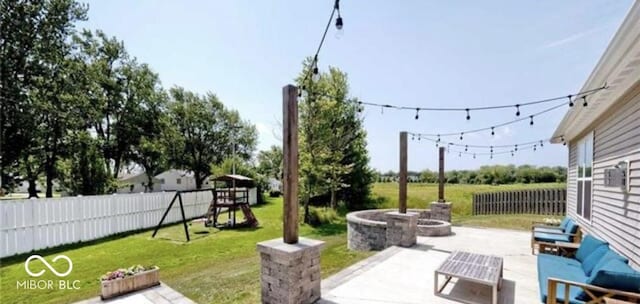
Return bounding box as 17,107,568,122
538,235,640,304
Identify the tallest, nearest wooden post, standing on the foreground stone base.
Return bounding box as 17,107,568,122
282,84,298,244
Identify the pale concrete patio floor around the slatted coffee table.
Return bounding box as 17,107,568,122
319,227,540,304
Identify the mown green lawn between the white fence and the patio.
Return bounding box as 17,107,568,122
0,198,371,303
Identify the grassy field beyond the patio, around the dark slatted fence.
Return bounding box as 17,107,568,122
372,183,565,229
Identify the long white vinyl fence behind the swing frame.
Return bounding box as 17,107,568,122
0,191,212,257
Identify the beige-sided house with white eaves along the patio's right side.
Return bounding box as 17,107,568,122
552,2,640,267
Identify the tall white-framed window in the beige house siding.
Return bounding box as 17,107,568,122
576,132,593,221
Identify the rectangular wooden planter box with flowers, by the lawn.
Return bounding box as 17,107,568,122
100,267,160,300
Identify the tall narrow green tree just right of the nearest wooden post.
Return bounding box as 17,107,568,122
298,61,373,216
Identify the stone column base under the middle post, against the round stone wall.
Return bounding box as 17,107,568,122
386,211,418,247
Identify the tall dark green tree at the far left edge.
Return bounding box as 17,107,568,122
0,0,87,197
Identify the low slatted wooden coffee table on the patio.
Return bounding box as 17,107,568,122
433,251,503,304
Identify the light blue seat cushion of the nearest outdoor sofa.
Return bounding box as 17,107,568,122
538,254,588,303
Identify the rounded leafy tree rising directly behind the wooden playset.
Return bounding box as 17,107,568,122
169,87,257,189
